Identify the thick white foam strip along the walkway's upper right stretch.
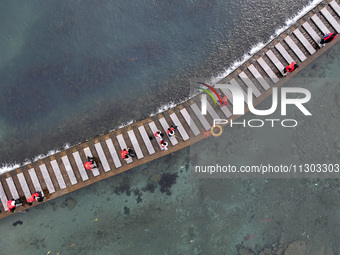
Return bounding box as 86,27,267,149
208,0,323,84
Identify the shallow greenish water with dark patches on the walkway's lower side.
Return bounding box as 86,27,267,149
0,39,340,255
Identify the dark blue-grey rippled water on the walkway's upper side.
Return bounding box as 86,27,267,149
0,0,314,164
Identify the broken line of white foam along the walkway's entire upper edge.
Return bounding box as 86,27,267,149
0,0,322,174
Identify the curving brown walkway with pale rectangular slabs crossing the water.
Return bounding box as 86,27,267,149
0,0,340,219
